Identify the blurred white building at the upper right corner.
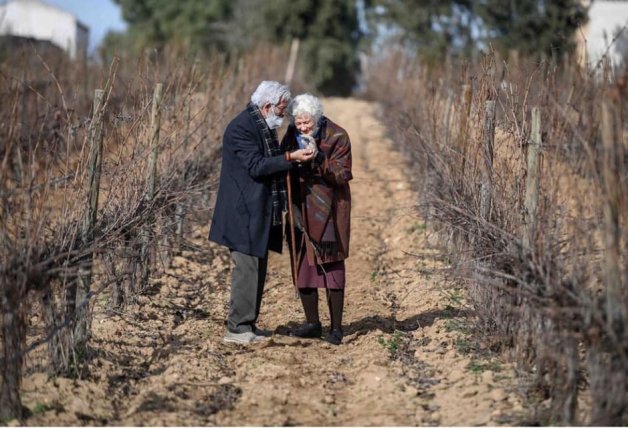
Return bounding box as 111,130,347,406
576,0,628,66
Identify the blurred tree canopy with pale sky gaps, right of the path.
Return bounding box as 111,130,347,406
371,0,587,60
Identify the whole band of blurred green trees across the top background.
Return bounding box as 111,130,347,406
106,0,586,95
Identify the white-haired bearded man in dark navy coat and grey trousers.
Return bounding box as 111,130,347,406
209,81,314,344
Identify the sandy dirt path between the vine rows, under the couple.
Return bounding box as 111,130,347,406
19,99,523,426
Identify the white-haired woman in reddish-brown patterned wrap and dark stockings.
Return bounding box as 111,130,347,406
282,94,352,345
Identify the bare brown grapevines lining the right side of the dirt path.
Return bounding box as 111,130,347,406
369,50,628,425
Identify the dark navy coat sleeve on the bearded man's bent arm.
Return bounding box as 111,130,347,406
230,123,291,179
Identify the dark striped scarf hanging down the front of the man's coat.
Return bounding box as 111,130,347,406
246,103,288,226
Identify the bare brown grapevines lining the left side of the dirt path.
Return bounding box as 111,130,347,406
0,47,290,418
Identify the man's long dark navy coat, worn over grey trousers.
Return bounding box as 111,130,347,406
209,109,291,257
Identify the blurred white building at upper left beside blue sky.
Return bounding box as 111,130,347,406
0,0,91,58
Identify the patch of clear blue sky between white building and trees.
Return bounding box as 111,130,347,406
42,0,126,53
